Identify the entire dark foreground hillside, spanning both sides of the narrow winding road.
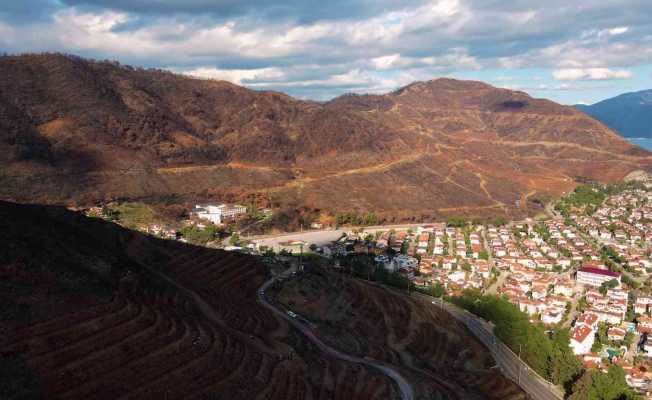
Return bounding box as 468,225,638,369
0,201,525,400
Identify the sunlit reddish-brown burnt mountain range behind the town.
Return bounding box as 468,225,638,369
0,54,652,216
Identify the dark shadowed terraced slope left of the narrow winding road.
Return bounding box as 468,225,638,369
0,203,397,400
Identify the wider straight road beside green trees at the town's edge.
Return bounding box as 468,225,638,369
415,293,564,400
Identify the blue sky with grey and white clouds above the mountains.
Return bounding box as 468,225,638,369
0,0,652,104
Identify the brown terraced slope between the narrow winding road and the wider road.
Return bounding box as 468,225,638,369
275,269,525,400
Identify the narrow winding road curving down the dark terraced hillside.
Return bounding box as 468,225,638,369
258,278,414,400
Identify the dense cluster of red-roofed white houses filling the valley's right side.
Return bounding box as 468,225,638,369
352,186,652,394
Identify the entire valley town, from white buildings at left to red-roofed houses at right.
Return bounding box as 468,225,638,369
87,183,652,398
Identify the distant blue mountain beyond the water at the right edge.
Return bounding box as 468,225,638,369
575,89,652,138
